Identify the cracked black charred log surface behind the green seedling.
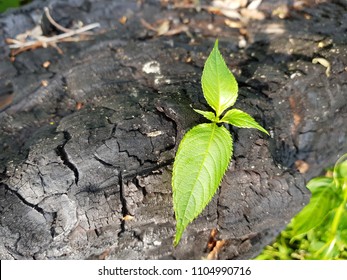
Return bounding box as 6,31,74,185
0,0,347,259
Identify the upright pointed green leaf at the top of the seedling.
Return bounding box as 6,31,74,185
201,40,238,117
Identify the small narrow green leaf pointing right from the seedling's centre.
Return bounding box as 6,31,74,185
220,109,269,135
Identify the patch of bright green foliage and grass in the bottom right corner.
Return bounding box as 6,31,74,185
255,154,347,260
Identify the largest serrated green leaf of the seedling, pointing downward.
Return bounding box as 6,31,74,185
172,123,232,246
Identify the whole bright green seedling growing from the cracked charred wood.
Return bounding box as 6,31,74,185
172,40,268,246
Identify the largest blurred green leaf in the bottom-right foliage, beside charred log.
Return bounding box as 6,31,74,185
292,178,341,236
